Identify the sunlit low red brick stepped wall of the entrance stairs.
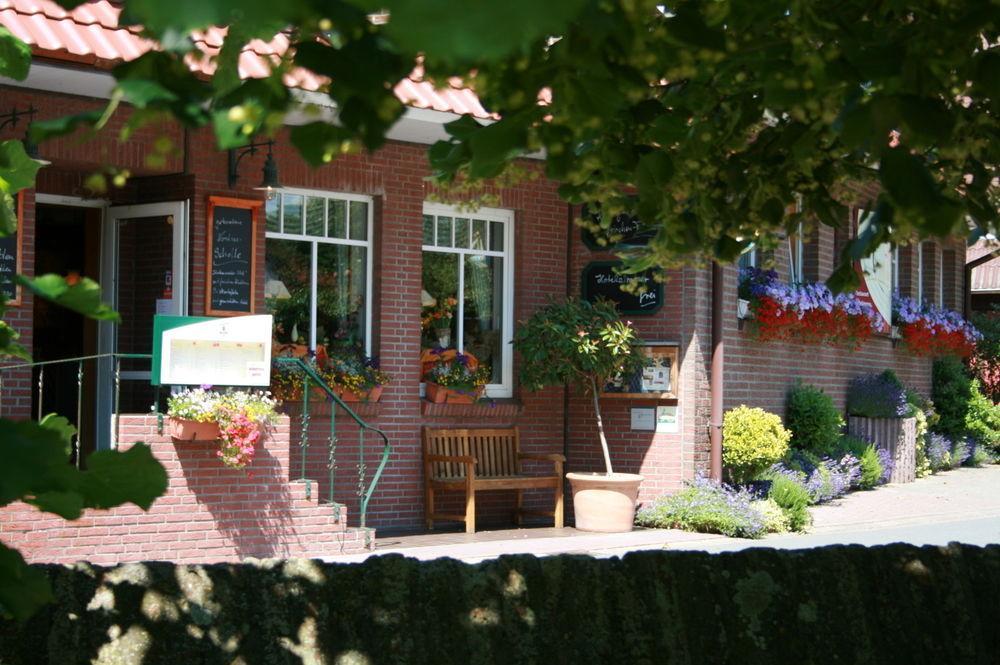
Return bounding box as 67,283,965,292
0,416,374,565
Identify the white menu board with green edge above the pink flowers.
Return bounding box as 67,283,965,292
151,314,274,386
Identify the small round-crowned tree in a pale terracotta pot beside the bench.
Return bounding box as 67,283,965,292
514,299,645,532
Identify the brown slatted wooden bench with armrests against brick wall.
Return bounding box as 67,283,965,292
423,427,566,533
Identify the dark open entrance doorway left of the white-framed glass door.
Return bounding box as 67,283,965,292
31,203,102,457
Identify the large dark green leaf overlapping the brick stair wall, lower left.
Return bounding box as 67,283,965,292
80,443,167,510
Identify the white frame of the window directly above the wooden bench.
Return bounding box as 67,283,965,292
420,201,514,398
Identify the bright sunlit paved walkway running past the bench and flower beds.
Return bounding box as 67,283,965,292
329,466,1000,563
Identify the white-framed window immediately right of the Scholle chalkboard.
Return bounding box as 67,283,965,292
264,189,372,355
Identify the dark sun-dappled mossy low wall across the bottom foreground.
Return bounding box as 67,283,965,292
0,545,1000,665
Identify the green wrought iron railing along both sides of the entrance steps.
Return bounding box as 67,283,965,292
0,353,392,527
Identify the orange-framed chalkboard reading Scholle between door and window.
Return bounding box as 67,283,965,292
205,196,261,316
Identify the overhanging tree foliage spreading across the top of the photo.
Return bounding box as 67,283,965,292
0,0,1000,278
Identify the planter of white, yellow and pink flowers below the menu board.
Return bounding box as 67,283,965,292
167,387,277,469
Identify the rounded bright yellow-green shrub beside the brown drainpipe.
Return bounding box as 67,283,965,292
722,405,792,483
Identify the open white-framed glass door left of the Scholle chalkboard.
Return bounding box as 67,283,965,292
97,201,189,449
